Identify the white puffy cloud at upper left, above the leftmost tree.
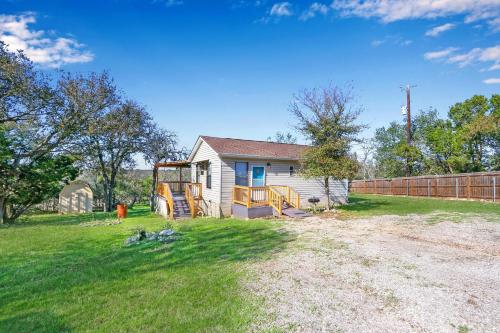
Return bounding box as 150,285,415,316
0,14,94,68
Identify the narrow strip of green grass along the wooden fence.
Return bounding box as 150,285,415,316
339,194,500,218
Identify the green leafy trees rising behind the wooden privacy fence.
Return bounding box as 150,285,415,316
374,95,500,177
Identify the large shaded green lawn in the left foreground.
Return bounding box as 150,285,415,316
0,208,291,332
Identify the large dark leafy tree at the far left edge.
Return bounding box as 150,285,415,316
0,43,84,223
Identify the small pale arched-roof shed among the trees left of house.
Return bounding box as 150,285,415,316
59,181,94,214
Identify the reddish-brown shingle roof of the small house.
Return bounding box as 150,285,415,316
200,135,309,160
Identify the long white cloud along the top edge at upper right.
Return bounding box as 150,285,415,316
332,0,500,27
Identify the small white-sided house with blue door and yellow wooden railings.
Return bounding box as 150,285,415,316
157,136,348,218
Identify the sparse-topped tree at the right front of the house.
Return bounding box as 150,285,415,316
290,86,364,209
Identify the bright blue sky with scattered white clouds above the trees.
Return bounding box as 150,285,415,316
0,0,500,154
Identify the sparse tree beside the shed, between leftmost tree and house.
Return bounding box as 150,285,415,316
62,73,151,212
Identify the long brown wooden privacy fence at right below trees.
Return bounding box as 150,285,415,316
349,172,500,202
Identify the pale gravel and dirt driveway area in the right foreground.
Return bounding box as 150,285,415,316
248,214,500,332
